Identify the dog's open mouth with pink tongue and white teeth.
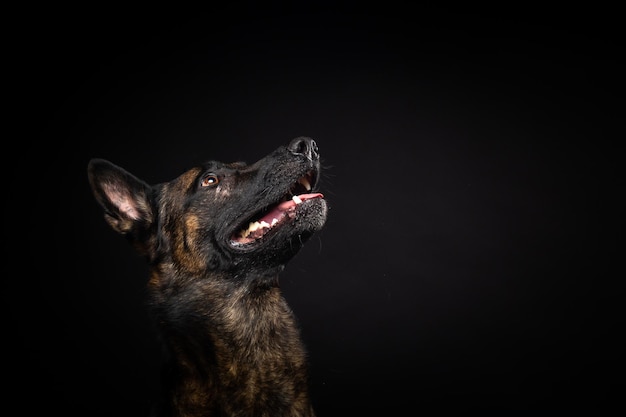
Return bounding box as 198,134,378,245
230,172,324,246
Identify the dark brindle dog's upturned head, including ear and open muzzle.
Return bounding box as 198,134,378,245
88,137,328,276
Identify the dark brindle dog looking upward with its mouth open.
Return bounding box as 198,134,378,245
87,137,328,417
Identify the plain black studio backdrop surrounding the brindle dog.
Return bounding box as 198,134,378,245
8,5,624,417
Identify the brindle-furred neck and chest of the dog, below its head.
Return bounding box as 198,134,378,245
150,273,314,417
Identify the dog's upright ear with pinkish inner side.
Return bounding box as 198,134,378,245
87,159,154,235
